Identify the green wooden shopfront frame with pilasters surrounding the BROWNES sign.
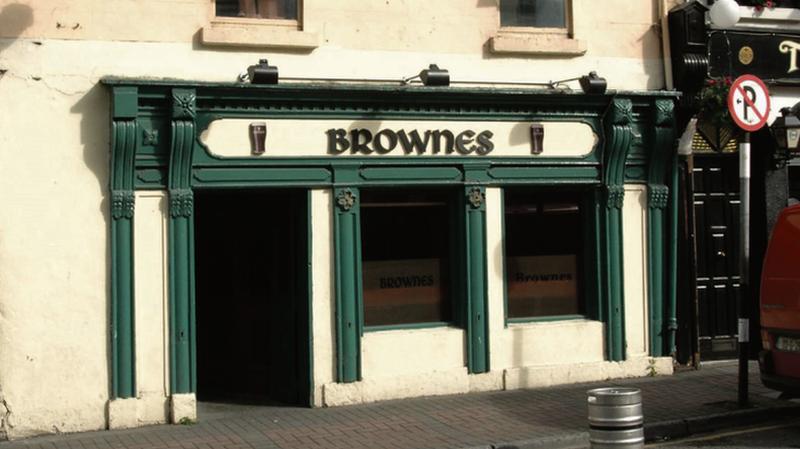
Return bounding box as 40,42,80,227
103,78,675,397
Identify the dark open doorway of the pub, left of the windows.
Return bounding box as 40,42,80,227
195,190,311,405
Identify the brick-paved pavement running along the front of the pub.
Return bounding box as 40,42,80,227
0,362,800,449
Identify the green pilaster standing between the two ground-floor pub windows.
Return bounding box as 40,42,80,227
464,186,489,374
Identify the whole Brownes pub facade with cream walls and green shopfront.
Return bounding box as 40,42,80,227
0,0,677,438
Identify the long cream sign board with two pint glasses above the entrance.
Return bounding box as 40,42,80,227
200,117,599,159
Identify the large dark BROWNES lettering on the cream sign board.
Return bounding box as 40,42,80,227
325,128,494,156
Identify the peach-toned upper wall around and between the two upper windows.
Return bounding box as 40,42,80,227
0,0,660,59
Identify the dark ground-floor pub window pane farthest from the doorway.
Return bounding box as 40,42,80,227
505,192,584,318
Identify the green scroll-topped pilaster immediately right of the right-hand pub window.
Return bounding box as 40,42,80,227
603,98,633,361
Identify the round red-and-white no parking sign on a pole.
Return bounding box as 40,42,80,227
728,75,770,131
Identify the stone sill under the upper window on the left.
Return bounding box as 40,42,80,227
201,18,319,50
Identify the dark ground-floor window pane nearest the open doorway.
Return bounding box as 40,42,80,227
361,190,452,326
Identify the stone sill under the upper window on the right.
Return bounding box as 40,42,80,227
489,31,586,57
